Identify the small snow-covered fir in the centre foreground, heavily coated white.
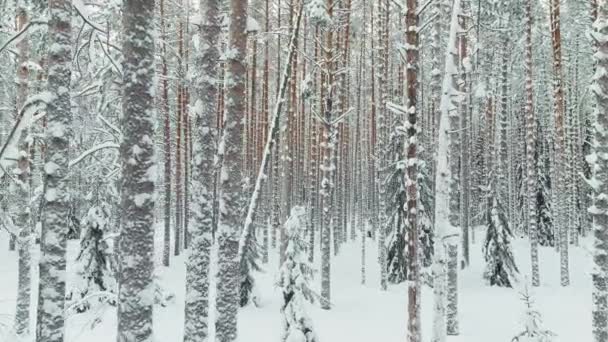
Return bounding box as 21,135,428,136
278,206,318,342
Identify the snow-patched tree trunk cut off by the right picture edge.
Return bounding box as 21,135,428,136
587,0,608,342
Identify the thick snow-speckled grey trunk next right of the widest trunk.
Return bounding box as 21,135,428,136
184,0,221,342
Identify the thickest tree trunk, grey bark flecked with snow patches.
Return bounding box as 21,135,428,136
117,0,156,342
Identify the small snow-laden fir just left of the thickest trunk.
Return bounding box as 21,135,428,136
66,202,117,313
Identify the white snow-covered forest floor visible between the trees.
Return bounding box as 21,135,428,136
0,226,592,342
